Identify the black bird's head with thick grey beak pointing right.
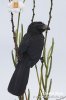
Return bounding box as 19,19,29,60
27,22,50,34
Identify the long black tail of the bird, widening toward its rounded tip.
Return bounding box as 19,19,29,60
8,62,30,96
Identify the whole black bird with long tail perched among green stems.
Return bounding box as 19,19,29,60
8,22,50,96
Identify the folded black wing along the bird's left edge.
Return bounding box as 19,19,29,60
18,34,30,56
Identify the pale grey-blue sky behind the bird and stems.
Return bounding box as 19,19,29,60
0,0,66,100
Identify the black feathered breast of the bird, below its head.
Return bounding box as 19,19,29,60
28,35,44,60
